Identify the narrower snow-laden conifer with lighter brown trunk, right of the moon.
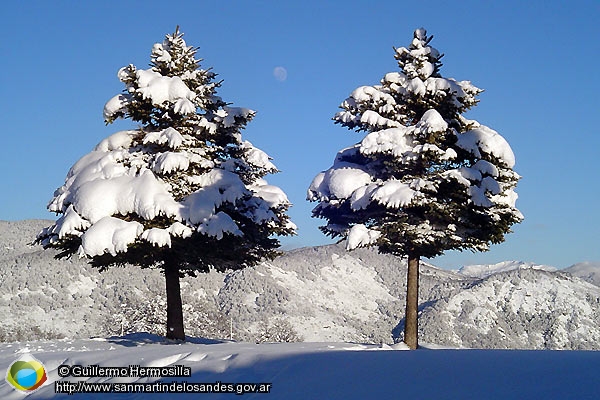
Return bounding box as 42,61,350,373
308,28,523,348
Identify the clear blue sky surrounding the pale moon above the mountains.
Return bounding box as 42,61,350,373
0,0,600,268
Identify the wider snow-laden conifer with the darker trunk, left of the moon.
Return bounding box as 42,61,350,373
38,28,295,340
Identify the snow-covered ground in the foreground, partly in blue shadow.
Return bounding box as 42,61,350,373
0,334,600,400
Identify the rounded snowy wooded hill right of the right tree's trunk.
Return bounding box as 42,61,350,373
421,269,600,349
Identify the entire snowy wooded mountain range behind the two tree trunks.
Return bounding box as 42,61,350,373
0,220,600,349
